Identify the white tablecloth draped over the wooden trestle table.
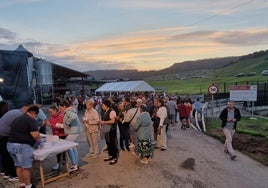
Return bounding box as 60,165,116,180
34,139,78,161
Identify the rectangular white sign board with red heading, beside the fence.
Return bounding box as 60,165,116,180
230,85,257,101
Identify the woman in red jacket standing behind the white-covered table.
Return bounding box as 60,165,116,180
46,105,67,170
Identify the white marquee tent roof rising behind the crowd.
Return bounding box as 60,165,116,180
95,81,155,92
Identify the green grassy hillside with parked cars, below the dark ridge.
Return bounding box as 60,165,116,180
146,54,268,94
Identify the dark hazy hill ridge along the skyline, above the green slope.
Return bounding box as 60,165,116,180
85,50,268,81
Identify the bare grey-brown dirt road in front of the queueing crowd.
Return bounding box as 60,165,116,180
43,127,268,188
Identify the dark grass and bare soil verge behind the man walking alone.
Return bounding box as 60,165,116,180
206,117,268,166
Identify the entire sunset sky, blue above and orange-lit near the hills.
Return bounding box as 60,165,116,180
0,0,268,71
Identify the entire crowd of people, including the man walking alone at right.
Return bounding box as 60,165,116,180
0,94,241,188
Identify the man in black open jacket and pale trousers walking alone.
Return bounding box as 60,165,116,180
219,101,241,160
